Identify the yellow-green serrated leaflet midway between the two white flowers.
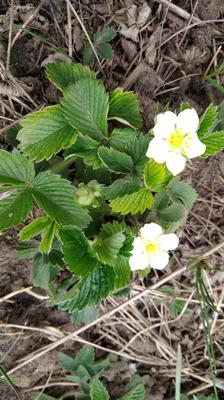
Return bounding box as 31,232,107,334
110,188,154,215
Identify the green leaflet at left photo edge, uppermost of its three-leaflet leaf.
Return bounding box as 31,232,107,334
0,149,35,185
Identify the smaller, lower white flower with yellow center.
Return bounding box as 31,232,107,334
129,223,179,271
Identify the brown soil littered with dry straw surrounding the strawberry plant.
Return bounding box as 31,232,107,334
0,0,224,400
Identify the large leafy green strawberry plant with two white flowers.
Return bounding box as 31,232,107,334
0,61,224,321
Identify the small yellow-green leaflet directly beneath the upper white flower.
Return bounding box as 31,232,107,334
144,160,172,192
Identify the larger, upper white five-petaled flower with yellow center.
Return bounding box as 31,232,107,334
146,108,206,175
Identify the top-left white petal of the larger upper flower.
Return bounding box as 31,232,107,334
153,111,177,139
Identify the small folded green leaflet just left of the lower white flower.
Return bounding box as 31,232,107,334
94,232,125,265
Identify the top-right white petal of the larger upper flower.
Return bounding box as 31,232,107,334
176,108,199,133
